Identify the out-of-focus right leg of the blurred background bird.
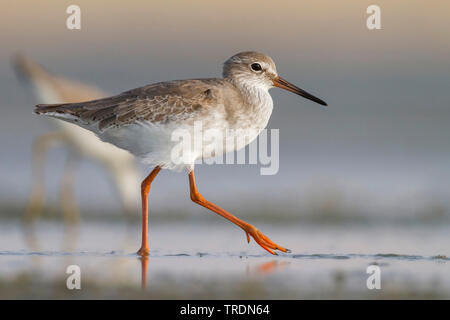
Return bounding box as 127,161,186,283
60,150,80,225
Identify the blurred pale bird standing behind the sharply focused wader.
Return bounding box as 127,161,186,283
12,54,140,223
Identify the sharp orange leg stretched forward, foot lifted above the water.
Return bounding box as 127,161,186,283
189,171,290,255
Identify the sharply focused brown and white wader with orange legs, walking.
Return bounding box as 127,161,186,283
35,51,327,256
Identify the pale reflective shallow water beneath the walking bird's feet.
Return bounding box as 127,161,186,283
0,220,450,299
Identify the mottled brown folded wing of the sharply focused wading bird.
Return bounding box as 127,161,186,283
35,79,221,130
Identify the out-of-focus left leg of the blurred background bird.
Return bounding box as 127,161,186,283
25,132,65,223
